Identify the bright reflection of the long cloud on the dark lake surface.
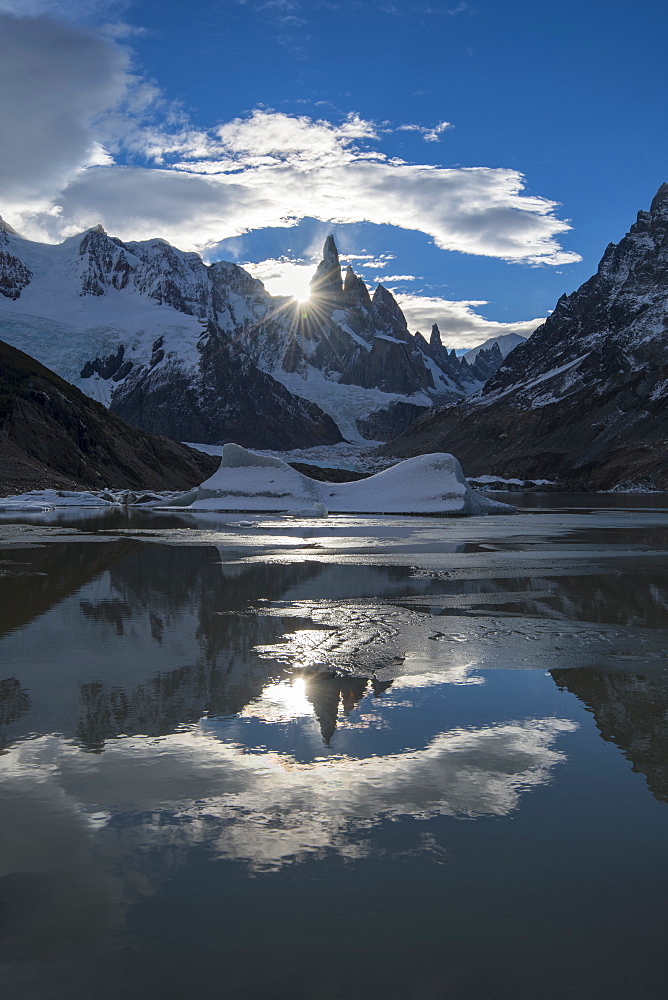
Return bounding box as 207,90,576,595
5,718,576,870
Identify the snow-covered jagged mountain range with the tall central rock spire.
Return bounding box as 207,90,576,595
0,224,499,448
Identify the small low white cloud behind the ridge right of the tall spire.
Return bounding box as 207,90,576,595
394,292,544,348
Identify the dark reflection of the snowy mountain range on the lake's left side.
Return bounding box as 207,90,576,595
0,541,423,750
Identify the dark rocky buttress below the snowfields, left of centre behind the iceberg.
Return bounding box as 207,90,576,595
111,323,341,449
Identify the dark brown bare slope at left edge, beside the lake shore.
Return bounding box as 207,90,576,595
0,341,219,496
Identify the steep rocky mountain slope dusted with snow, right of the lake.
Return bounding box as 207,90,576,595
386,184,668,489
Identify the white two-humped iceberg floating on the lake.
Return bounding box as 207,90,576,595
179,444,516,516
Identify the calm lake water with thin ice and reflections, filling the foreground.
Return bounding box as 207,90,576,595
0,494,668,1000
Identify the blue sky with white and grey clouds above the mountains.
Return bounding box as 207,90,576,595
0,0,668,347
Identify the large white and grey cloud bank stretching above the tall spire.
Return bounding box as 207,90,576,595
0,14,580,267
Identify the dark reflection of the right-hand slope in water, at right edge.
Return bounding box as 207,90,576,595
551,668,668,802
